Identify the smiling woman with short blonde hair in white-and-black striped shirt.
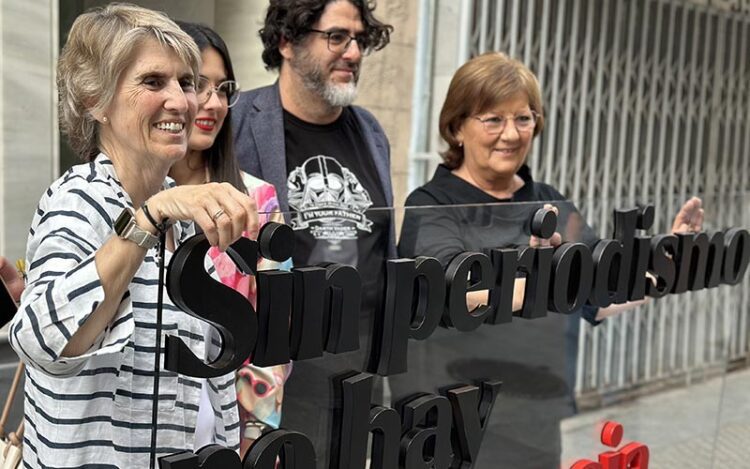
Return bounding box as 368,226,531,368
9,4,258,468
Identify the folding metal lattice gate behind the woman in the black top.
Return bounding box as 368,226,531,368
440,0,750,399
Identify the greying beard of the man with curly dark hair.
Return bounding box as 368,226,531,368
289,47,359,107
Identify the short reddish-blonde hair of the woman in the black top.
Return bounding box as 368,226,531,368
439,52,544,169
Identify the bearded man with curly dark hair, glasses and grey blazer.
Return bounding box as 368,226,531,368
232,0,396,467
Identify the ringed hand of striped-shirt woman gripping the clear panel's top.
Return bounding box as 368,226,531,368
147,182,258,251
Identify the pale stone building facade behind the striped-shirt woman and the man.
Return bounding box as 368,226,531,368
0,0,419,259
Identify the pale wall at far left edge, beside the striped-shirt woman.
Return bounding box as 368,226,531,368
0,0,59,260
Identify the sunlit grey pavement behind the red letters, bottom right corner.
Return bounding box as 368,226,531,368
561,370,750,469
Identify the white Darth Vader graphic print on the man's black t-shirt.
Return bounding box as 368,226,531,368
287,155,372,240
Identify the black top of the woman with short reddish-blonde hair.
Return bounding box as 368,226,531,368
398,165,598,324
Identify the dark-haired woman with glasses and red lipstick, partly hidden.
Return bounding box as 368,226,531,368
169,21,291,455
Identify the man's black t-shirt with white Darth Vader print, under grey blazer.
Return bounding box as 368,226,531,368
284,107,390,315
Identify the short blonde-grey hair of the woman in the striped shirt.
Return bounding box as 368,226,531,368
57,3,201,161
